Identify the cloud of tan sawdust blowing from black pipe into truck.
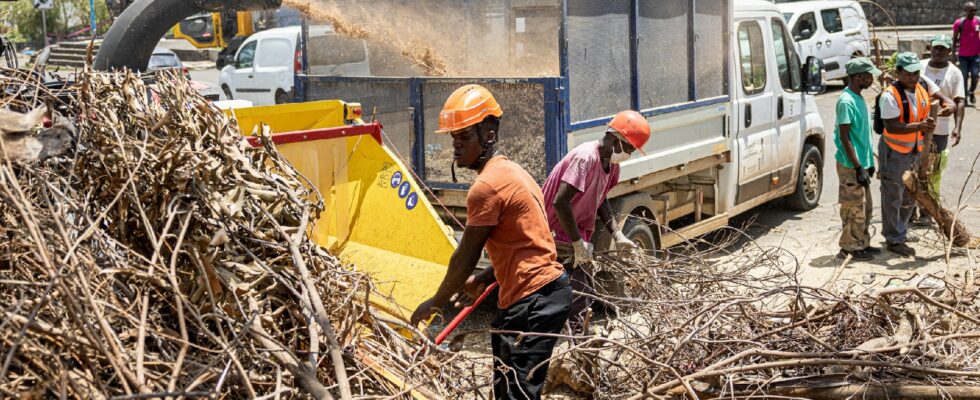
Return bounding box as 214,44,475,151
283,0,559,77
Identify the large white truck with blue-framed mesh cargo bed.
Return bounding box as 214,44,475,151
295,0,825,249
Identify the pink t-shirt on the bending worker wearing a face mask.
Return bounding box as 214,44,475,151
542,141,619,243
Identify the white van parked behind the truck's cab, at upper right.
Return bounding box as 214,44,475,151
777,1,871,80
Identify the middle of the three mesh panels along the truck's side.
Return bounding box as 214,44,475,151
636,0,700,109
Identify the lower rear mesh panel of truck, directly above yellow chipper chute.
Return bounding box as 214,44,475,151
309,78,415,165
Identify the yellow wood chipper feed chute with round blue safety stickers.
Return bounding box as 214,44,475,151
229,100,456,321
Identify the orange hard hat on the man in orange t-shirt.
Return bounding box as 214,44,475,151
436,85,504,133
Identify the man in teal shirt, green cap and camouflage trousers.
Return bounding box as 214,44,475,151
834,57,881,261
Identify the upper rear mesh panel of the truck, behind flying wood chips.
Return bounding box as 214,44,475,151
308,0,561,78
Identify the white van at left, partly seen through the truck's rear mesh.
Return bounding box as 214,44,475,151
219,26,371,106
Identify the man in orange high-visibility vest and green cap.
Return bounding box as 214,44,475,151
877,52,956,257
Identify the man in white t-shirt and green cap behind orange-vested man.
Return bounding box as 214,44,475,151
917,34,966,226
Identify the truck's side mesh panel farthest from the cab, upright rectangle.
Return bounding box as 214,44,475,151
567,0,631,122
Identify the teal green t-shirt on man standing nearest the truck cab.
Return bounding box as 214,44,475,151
834,88,875,168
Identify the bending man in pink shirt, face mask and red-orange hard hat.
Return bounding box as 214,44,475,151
542,111,650,331
